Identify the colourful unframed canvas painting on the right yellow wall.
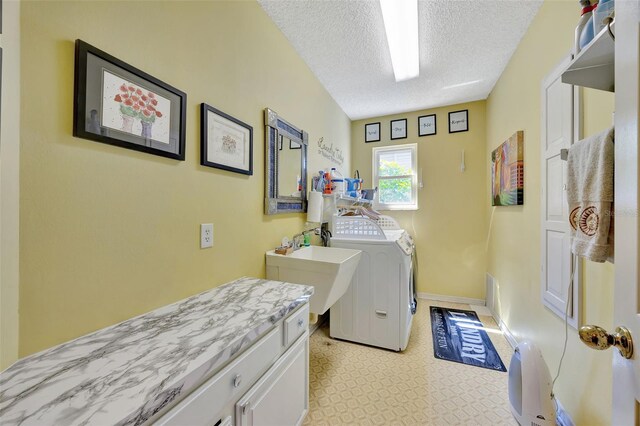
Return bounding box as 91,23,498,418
491,130,524,206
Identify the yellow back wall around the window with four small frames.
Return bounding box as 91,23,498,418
351,101,489,299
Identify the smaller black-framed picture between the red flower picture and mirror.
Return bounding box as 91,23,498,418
200,103,253,176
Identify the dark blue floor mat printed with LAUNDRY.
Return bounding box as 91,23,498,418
430,306,507,371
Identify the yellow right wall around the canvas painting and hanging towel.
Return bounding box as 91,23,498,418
485,0,614,425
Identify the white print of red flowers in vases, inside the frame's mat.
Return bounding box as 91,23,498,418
102,71,170,143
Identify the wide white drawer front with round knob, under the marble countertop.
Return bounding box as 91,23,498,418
155,327,281,425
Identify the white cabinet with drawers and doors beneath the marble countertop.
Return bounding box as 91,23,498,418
155,303,309,426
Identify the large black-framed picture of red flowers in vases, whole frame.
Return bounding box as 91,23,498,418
73,40,187,160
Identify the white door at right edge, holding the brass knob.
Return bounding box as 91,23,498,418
608,0,640,425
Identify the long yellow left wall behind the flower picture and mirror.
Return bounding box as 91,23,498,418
20,1,350,356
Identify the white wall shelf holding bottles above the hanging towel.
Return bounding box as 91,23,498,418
562,21,615,92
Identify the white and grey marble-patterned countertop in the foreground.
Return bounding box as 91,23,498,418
0,277,313,426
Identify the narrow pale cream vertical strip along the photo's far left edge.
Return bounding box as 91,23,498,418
0,1,20,370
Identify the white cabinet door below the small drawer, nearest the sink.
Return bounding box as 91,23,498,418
236,332,309,426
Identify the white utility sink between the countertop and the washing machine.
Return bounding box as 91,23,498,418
267,246,362,315
